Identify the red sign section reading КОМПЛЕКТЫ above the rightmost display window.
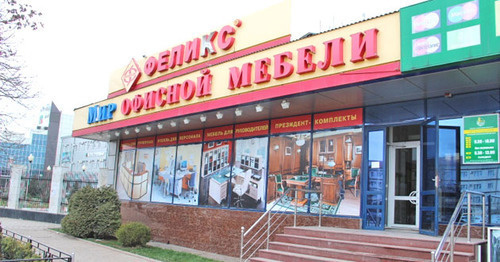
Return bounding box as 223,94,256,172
314,108,363,130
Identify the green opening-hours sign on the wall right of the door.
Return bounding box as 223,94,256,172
463,114,499,164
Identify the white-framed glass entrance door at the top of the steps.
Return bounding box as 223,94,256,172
387,141,420,229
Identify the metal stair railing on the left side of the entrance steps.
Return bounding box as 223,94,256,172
240,188,323,261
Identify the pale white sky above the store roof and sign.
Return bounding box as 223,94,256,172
12,0,421,134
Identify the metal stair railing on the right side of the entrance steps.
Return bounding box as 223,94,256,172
431,191,486,262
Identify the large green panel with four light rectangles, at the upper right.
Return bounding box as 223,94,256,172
400,0,500,72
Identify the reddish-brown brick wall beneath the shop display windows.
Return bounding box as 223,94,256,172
121,202,361,257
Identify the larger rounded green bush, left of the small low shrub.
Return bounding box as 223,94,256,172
61,186,121,238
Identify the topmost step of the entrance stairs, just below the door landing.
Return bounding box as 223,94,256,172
284,227,475,253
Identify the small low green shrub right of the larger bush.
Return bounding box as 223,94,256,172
116,222,151,247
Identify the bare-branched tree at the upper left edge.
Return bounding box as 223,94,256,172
0,0,43,142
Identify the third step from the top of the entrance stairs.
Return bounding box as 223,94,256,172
269,242,430,262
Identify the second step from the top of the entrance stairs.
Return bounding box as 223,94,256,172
274,234,473,261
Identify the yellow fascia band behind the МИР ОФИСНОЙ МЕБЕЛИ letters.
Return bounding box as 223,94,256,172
73,8,400,134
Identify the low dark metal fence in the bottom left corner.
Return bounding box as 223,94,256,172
0,225,74,262
